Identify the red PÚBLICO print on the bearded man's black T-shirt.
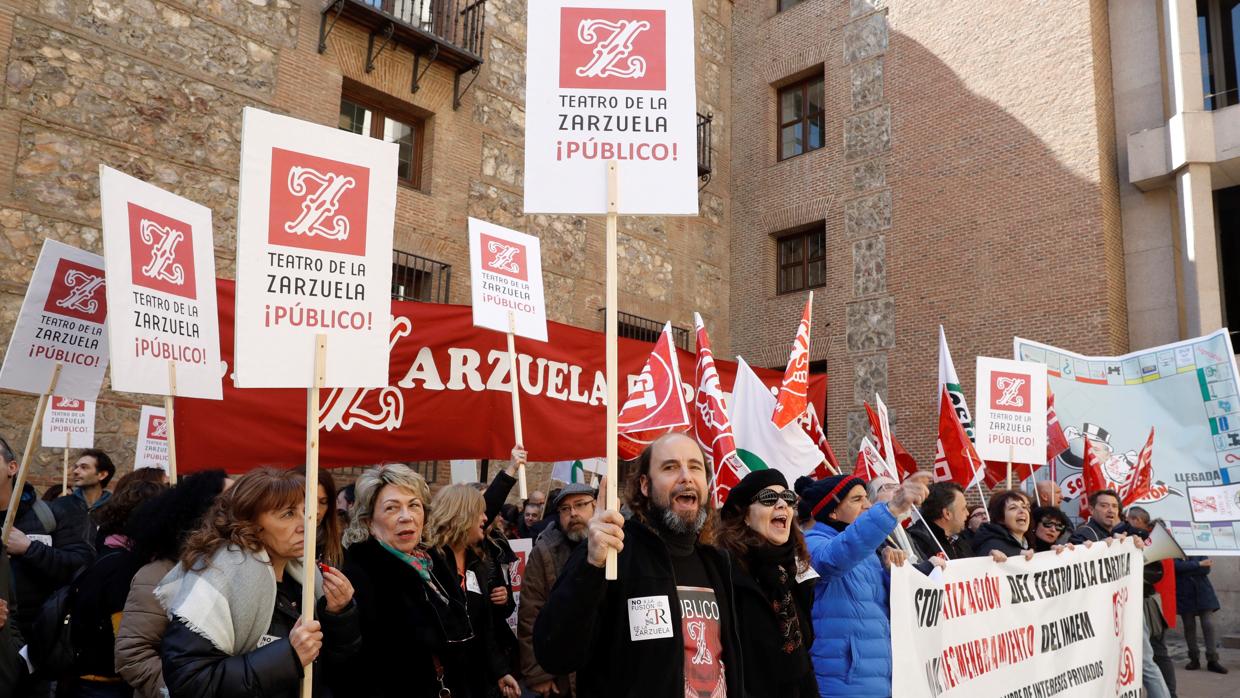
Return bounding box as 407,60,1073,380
676,586,728,698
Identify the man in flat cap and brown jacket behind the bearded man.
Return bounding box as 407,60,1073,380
517,482,598,697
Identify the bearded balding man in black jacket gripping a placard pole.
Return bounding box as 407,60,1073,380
534,433,744,698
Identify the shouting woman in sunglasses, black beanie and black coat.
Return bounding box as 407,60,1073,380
715,470,818,698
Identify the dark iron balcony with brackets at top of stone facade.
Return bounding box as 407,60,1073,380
319,0,486,109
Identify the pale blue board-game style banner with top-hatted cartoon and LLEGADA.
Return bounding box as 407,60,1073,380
1014,329,1240,555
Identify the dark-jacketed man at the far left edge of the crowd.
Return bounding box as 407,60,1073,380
0,438,94,696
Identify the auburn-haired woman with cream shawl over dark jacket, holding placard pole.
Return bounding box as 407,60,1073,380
155,467,361,698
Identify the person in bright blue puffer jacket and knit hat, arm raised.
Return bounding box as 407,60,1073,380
796,475,928,698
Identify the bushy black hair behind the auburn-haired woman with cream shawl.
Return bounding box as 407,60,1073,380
125,470,228,560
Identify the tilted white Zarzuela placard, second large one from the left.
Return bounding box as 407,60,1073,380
99,165,223,400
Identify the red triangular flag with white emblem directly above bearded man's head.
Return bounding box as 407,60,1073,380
618,322,689,460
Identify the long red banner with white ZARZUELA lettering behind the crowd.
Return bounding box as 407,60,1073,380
175,280,827,472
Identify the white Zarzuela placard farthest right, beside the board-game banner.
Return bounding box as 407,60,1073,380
973,356,1047,465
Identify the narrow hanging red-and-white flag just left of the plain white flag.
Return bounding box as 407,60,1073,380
693,312,749,507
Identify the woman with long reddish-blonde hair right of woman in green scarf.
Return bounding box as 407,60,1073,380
427,485,521,698
